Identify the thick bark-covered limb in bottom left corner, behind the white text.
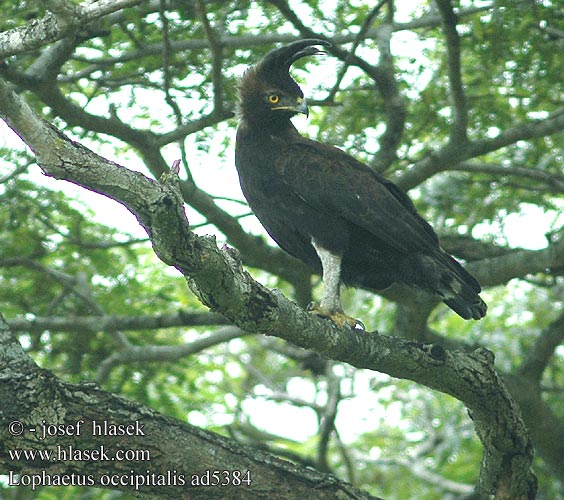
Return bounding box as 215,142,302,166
0,316,382,500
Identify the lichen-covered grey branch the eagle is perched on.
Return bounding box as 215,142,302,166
0,75,536,498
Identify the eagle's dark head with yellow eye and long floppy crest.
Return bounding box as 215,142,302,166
239,39,331,124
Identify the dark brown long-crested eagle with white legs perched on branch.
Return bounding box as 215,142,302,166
235,39,487,326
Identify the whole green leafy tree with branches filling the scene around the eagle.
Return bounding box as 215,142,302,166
0,0,564,500
